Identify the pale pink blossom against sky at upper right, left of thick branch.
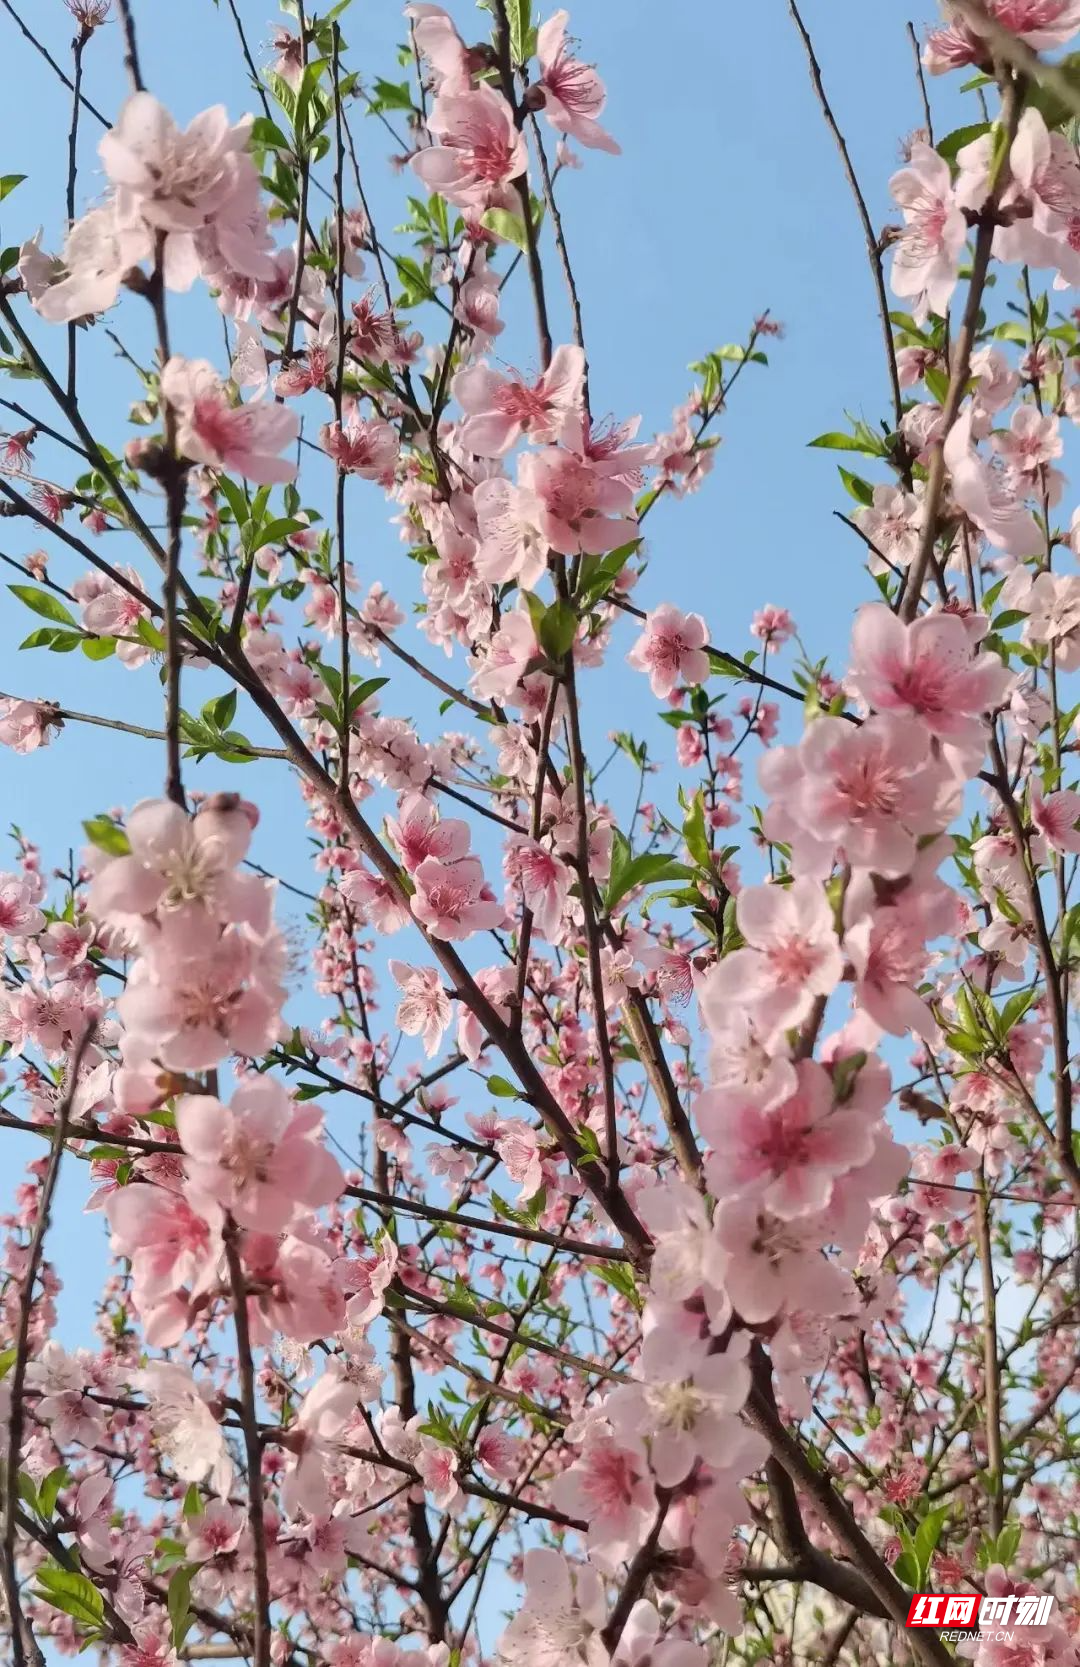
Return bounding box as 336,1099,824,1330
888,140,967,323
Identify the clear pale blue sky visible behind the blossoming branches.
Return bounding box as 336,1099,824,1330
0,0,973,1340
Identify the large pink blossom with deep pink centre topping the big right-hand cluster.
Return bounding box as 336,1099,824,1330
848,602,1013,757
